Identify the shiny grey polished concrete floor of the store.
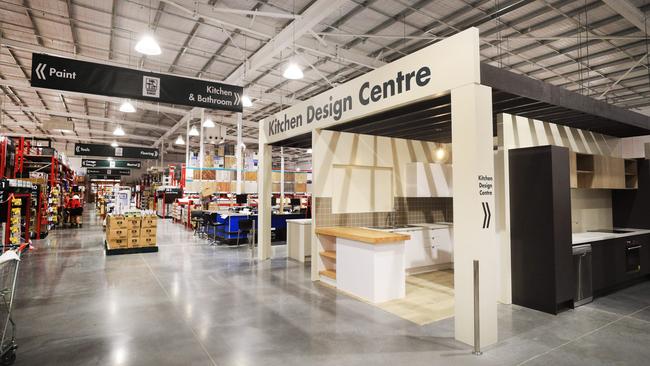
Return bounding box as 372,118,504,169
10,210,650,366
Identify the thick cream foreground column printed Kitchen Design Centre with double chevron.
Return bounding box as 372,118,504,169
451,84,499,347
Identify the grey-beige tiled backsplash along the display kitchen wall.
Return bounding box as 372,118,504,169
315,197,453,227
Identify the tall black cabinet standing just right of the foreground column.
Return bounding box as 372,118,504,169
509,146,575,314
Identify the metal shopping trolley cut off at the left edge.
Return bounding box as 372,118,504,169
0,244,28,366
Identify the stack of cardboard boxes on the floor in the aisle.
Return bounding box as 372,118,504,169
106,212,158,249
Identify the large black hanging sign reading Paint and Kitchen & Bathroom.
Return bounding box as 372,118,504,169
31,53,243,112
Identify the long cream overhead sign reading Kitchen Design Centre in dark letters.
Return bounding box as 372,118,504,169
261,28,480,143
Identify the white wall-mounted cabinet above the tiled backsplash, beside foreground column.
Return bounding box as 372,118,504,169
404,163,453,197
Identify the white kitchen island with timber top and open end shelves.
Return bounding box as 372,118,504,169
316,227,410,303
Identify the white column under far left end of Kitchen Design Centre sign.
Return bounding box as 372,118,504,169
257,130,273,260
